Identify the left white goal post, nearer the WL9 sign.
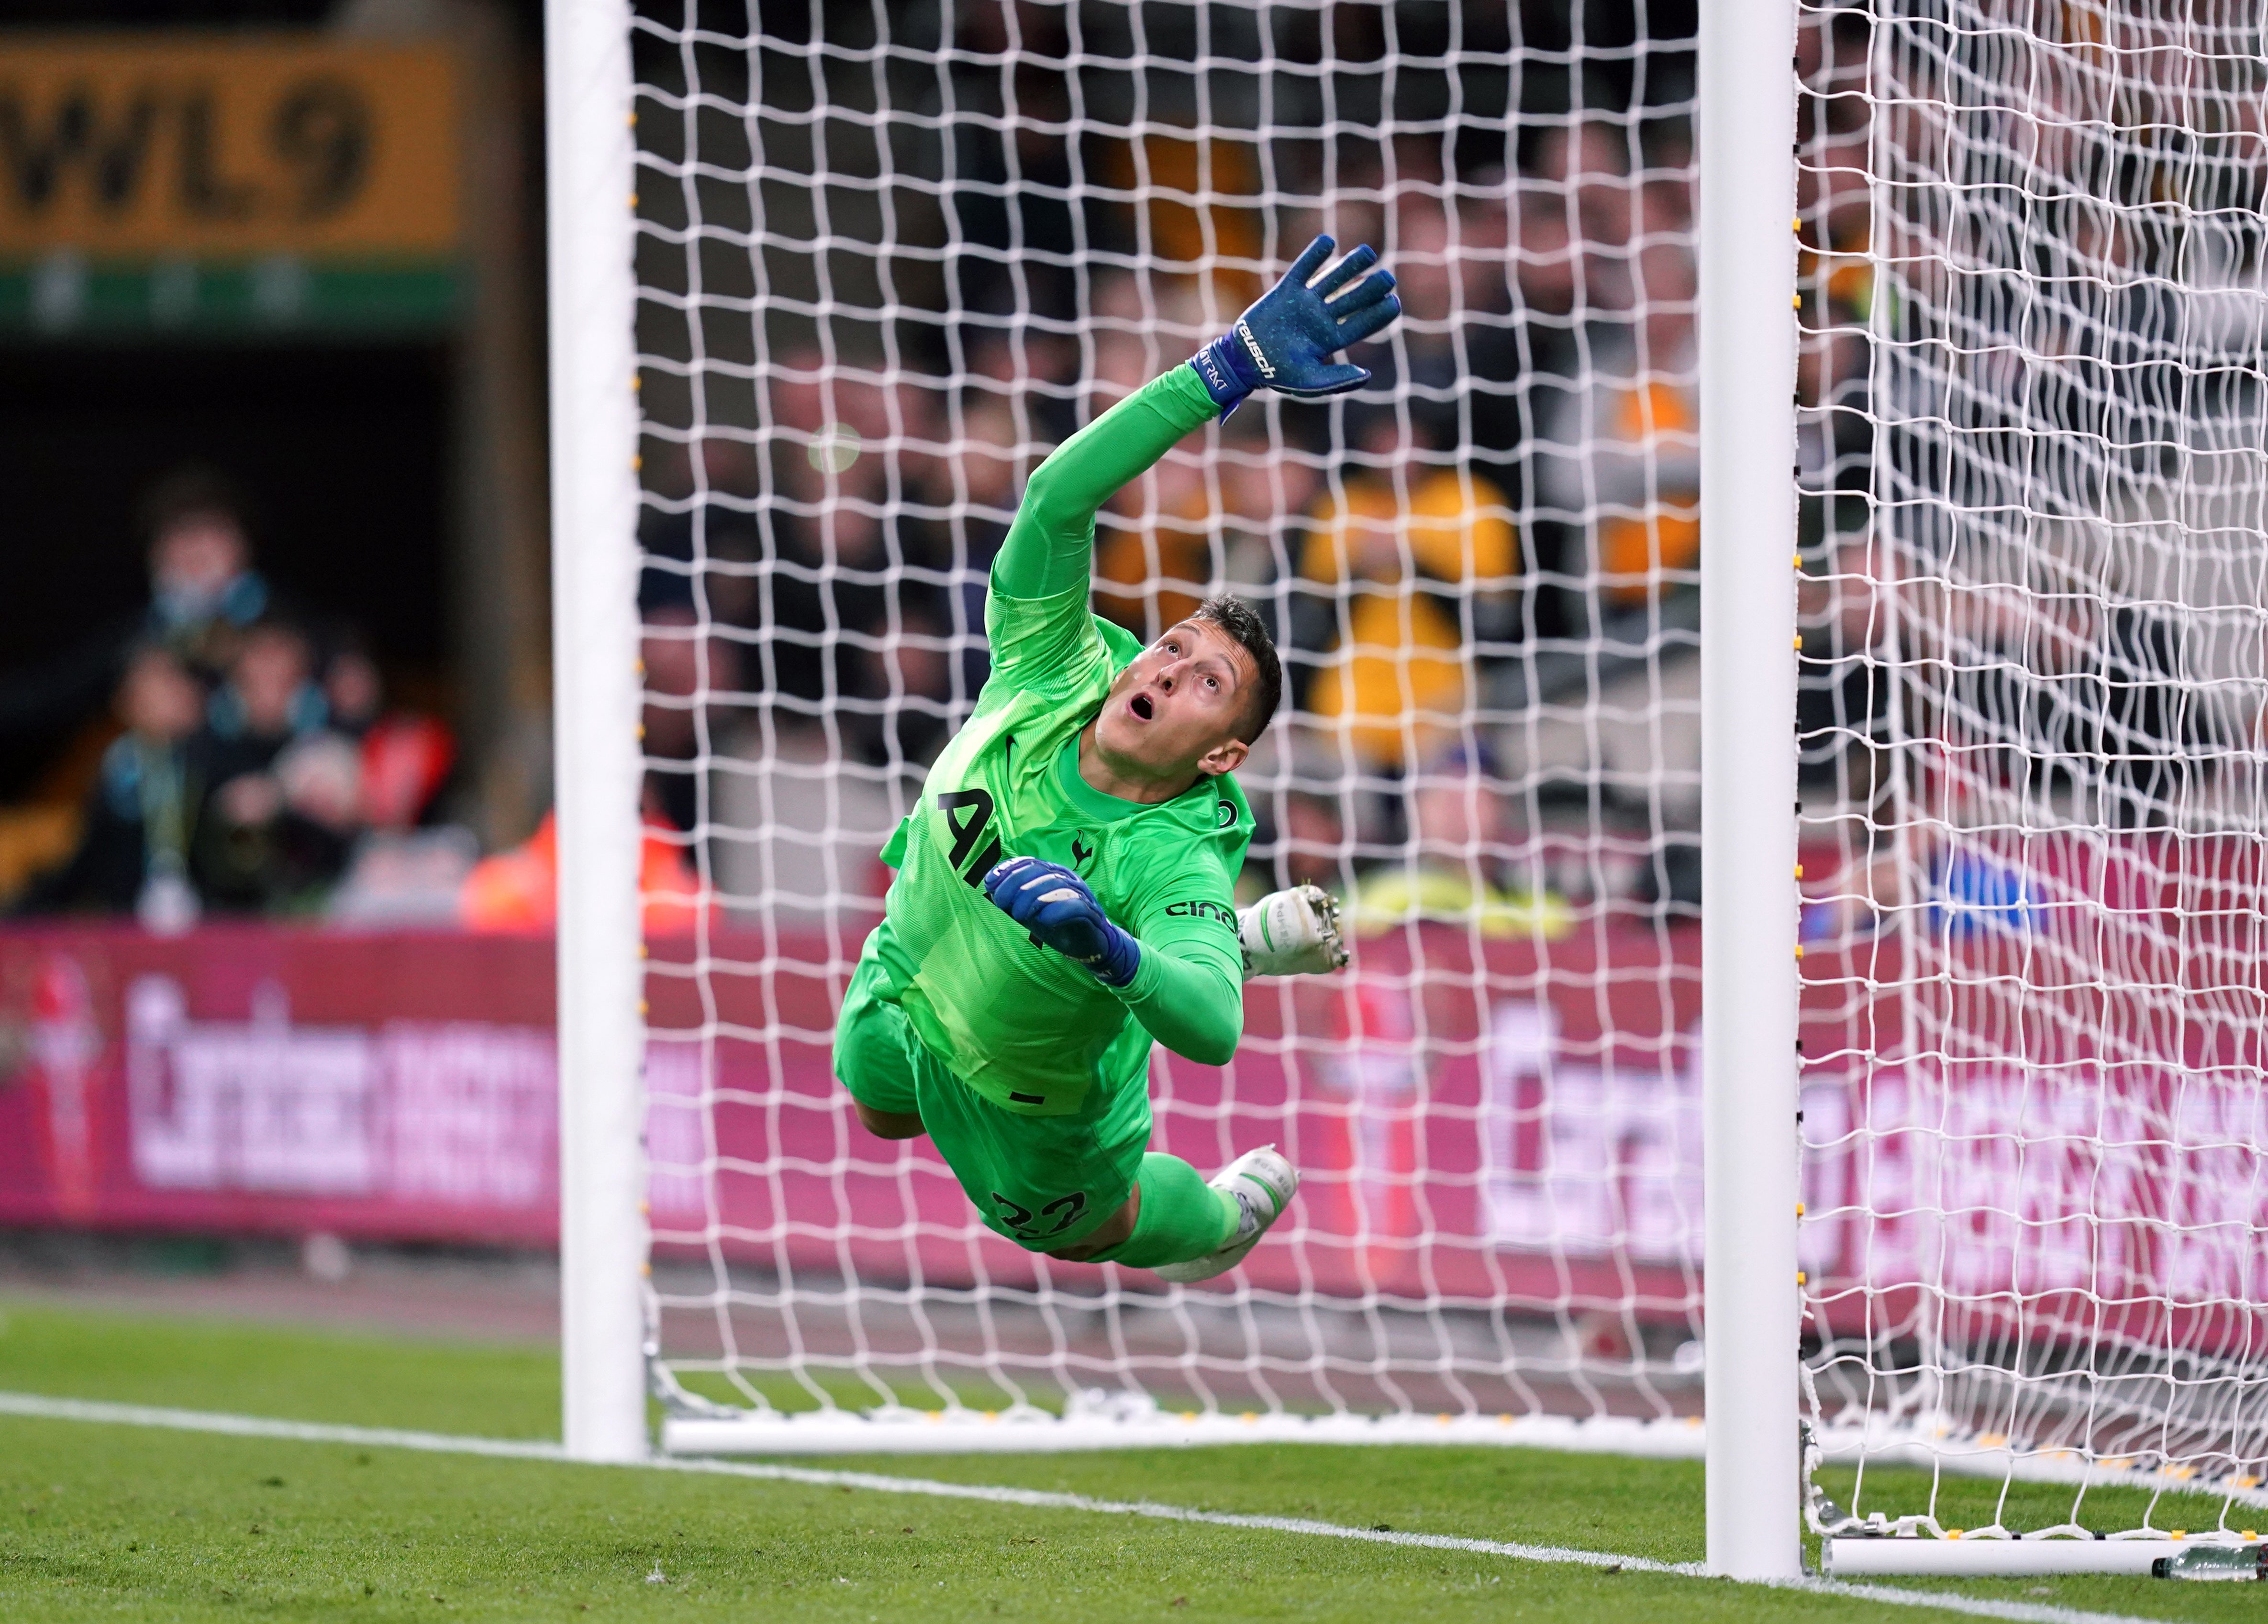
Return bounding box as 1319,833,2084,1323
545,0,646,1461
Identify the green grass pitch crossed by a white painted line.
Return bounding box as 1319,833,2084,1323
0,1302,2268,1624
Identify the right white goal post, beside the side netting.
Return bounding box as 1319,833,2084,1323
1699,0,1803,1579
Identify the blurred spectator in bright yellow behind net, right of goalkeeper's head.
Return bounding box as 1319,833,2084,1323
1293,424,1520,769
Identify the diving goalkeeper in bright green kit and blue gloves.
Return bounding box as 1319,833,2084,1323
834,238,1401,1282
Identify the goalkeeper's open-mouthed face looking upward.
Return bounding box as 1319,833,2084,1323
1095,619,1256,780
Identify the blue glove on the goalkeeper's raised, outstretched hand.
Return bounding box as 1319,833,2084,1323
1189,236,1401,417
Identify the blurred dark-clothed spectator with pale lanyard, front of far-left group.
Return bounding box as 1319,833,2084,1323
22,644,209,930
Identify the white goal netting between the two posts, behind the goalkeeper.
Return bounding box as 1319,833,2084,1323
633,0,1705,1452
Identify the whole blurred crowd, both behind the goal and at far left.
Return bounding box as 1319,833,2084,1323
18,19,2209,935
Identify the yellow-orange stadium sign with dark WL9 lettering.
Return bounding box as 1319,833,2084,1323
0,34,458,261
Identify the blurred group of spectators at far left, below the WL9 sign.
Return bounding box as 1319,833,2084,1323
0,467,476,930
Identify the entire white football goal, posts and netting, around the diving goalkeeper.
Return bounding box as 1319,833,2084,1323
546,0,2268,1579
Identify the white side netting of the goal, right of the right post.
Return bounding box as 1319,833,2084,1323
1796,0,2268,1536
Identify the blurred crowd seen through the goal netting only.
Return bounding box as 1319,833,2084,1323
644,6,2241,932
